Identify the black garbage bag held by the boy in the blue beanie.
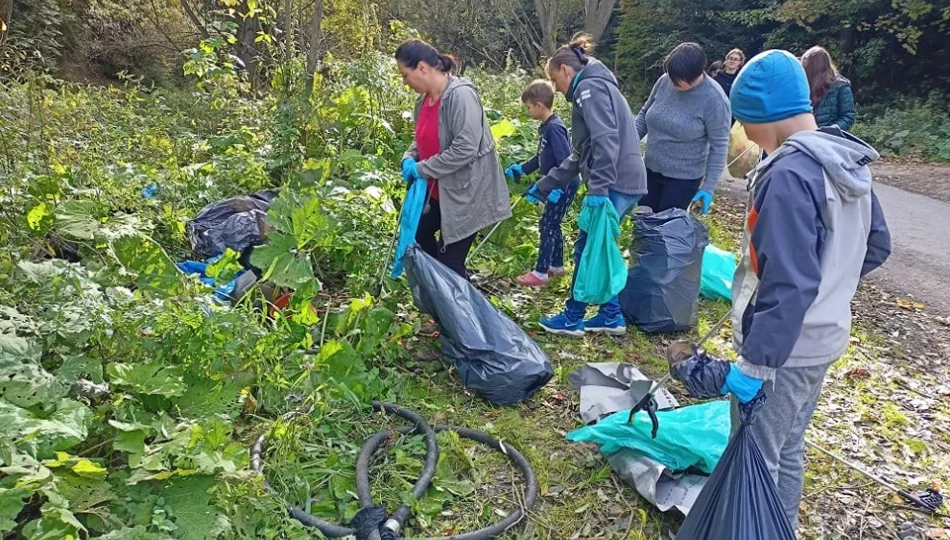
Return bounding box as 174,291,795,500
676,393,795,540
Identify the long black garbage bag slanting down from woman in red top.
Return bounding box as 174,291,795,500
405,245,554,405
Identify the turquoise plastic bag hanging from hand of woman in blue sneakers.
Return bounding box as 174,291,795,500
574,204,627,304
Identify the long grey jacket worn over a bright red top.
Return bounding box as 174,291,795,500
405,76,511,244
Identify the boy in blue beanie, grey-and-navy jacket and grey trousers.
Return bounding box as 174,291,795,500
672,50,890,527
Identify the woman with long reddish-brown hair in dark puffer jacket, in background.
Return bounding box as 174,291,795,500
802,47,855,131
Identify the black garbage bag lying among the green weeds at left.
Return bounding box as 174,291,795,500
185,191,277,260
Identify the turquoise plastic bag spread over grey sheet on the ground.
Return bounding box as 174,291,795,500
567,400,732,473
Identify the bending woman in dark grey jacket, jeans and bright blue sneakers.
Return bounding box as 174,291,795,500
528,34,647,336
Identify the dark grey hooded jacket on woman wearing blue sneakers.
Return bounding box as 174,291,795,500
538,58,647,195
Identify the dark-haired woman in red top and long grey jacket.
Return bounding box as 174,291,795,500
396,39,511,277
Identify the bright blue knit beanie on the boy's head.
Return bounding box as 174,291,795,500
729,50,812,124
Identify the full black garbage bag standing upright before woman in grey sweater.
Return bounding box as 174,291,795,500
620,208,709,332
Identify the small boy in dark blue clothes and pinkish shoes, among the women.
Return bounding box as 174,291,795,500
505,80,581,287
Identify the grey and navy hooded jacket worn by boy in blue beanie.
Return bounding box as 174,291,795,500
732,128,890,380
